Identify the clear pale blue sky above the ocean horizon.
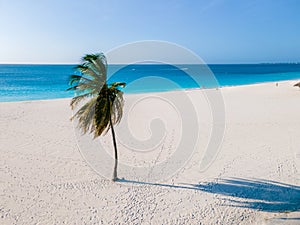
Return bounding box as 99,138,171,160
0,0,300,63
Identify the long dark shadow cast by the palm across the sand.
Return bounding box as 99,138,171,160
118,178,300,213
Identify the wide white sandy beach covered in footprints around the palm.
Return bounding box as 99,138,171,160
0,81,300,224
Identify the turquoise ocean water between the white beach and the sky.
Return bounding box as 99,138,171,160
0,64,300,102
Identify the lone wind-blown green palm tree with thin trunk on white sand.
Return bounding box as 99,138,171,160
68,53,126,181
